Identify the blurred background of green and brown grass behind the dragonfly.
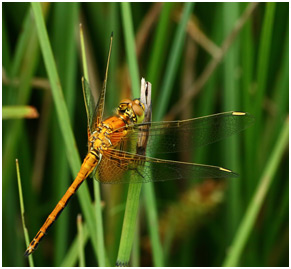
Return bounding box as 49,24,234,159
2,3,289,266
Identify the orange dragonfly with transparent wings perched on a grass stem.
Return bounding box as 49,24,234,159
24,36,254,256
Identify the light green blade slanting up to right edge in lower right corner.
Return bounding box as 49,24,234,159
223,119,289,267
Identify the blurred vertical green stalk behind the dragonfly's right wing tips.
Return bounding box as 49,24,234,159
222,3,242,239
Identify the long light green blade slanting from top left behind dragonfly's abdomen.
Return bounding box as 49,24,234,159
32,2,98,258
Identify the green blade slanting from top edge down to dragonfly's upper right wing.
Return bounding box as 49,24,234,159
153,2,194,121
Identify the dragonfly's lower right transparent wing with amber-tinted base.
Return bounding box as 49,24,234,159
96,149,237,184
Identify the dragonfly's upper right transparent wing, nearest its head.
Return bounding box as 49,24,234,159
111,112,254,155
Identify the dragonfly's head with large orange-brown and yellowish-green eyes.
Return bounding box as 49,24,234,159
117,99,145,123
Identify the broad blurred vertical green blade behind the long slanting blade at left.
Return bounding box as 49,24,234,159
51,3,80,266
